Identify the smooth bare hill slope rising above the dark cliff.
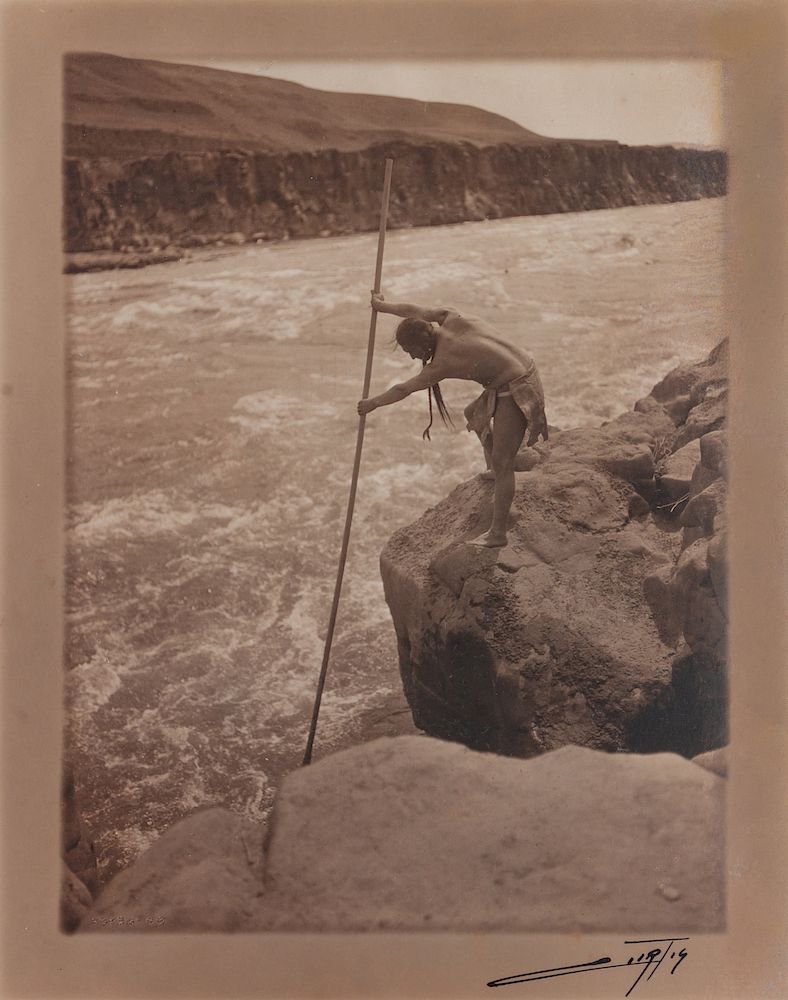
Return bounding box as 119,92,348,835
64,53,555,160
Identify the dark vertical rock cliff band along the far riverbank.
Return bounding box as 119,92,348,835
64,140,726,253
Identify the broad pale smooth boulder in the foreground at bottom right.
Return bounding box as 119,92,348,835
249,736,725,934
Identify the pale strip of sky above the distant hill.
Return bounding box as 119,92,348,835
199,57,724,146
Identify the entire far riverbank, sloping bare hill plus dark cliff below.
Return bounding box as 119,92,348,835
64,53,726,263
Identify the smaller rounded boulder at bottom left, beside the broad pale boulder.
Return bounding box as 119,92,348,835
79,809,263,932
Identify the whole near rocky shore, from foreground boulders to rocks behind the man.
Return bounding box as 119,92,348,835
62,341,728,933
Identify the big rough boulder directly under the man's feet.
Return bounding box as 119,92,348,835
381,462,677,755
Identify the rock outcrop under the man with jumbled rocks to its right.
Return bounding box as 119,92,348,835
381,342,727,757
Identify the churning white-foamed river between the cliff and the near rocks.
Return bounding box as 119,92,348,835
65,199,725,876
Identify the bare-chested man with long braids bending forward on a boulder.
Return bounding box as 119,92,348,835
358,292,547,548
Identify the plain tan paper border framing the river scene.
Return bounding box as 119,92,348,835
0,0,788,998
